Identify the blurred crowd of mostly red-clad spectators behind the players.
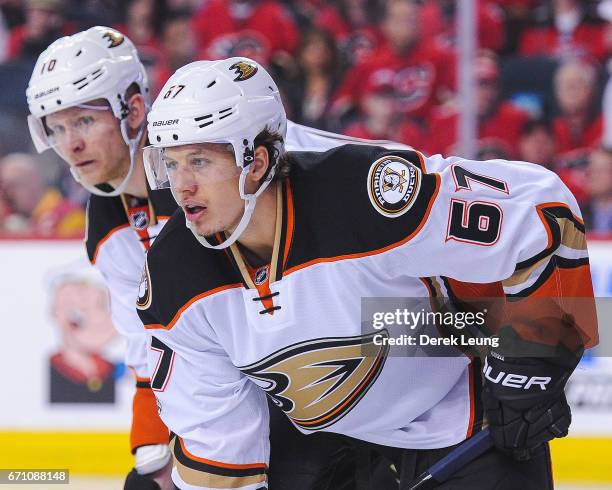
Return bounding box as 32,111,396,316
0,0,612,236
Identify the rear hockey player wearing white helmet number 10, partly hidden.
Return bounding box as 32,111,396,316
27,26,402,485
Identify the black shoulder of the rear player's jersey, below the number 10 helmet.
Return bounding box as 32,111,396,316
85,194,129,262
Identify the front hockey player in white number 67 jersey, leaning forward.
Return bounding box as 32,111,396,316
137,58,597,490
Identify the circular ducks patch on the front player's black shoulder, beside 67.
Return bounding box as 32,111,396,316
368,156,421,218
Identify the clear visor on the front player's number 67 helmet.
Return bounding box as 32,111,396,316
143,142,240,191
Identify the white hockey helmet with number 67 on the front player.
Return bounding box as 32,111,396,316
144,57,287,249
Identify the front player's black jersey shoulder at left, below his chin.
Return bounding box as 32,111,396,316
138,208,241,326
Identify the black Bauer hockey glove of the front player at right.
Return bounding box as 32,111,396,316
483,330,581,460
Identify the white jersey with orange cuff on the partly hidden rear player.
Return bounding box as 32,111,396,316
85,121,407,449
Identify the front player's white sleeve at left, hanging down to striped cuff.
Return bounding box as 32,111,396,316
139,255,270,490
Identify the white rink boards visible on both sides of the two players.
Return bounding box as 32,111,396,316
0,240,612,436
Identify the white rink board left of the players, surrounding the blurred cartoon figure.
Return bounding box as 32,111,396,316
0,240,134,431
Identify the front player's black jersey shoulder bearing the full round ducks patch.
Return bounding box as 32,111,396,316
287,145,439,268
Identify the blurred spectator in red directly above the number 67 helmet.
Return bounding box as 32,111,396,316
193,0,299,66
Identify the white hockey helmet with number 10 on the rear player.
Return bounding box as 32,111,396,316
26,26,149,196
